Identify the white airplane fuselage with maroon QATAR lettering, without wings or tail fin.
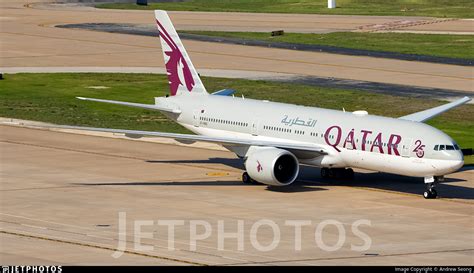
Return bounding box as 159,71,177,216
161,95,463,177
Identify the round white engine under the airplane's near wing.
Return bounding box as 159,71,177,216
245,147,300,186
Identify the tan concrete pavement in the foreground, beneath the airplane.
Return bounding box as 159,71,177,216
0,126,474,265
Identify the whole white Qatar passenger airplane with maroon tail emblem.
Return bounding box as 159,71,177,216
61,10,470,199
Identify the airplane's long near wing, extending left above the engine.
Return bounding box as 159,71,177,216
46,125,328,155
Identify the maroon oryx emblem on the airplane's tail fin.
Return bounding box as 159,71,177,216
156,20,195,96
